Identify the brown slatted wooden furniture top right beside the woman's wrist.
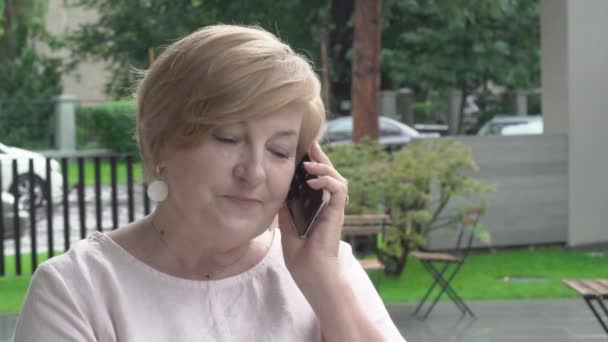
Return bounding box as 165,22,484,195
342,214,391,254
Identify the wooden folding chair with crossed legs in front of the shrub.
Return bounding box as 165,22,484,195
410,209,480,320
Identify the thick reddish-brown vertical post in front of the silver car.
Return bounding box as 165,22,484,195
351,0,381,142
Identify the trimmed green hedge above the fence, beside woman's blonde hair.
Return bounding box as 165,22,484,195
76,101,137,152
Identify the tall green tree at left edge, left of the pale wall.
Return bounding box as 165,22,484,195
0,0,62,149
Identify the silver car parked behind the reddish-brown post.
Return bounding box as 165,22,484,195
321,116,439,150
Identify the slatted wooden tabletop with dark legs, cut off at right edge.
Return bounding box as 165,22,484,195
562,279,608,334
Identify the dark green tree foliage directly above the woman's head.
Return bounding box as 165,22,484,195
67,0,327,98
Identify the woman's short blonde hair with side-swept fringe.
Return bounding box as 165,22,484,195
135,25,325,181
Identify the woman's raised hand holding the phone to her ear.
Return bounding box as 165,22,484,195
279,142,348,287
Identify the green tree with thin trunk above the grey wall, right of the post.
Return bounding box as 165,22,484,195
383,0,540,133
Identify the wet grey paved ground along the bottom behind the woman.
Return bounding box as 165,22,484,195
0,299,608,342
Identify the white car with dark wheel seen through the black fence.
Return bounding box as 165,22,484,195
0,143,63,208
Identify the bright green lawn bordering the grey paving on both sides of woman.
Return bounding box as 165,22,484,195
0,247,608,313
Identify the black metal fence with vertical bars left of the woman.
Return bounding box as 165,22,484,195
0,155,150,276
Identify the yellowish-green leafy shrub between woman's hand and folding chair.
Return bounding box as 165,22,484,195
328,139,494,275
